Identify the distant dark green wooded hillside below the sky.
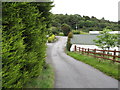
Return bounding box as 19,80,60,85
52,14,120,32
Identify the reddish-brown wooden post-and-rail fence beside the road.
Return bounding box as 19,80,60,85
74,45,120,63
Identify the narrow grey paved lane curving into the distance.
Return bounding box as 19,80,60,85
47,36,118,88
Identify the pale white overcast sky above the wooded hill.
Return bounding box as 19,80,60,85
51,0,120,21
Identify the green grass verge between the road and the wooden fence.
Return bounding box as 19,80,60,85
66,51,120,80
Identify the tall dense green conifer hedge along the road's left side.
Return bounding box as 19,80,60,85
2,2,52,88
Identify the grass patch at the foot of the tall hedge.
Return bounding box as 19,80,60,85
24,64,54,88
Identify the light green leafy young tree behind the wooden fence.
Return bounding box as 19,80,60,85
94,28,118,50
